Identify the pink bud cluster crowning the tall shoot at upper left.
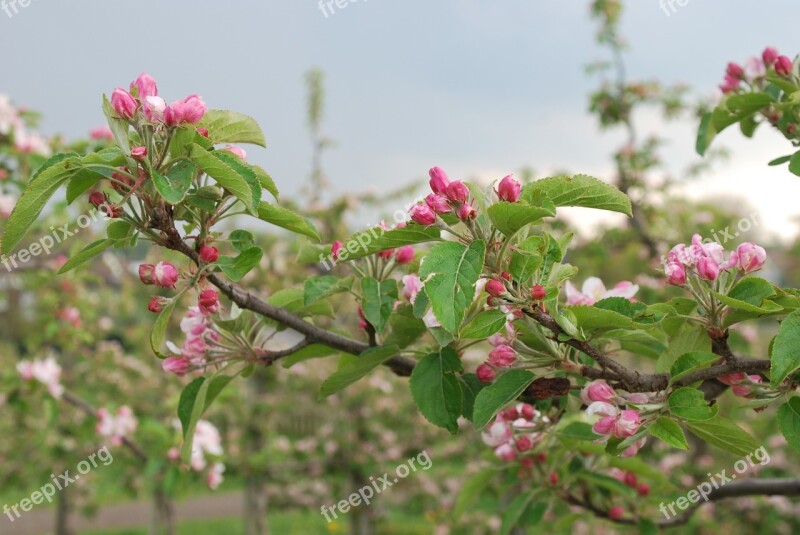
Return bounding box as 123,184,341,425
111,73,208,126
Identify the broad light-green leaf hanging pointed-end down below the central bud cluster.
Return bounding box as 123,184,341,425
419,240,485,334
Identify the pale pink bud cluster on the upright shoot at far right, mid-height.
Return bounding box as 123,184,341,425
664,234,767,286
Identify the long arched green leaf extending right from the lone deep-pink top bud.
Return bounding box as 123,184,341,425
521,175,632,217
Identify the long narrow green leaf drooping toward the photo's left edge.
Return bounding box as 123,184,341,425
0,153,80,254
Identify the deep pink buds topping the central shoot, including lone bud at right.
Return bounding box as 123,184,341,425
409,167,522,227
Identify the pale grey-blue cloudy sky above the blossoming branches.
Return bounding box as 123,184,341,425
0,0,800,238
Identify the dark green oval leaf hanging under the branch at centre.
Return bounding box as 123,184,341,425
409,347,463,434
